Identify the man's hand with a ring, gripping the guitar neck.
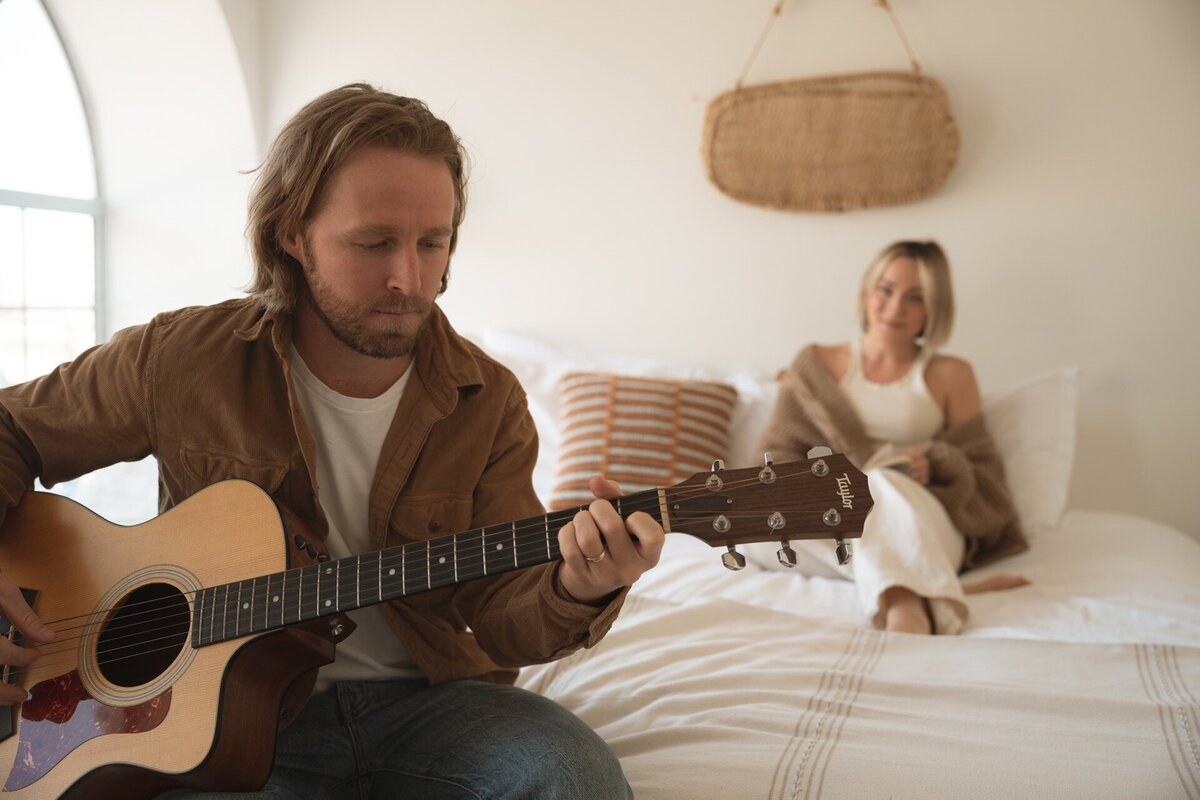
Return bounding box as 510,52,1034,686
558,475,664,603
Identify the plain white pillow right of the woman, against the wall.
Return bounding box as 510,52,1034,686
983,367,1079,540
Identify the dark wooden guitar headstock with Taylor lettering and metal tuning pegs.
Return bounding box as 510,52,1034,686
664,453,874,570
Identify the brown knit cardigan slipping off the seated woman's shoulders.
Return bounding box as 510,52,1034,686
762,345,1028,570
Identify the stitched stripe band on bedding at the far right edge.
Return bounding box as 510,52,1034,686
1135,644,1200,800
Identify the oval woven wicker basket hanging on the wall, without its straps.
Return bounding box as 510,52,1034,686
703,71,959,211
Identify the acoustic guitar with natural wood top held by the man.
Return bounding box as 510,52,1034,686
0,455,871,799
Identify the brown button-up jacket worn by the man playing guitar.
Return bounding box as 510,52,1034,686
0,299,625,684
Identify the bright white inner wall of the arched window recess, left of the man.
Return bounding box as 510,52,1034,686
47,0,258,332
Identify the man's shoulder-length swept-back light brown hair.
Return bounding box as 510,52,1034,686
246,83,467,312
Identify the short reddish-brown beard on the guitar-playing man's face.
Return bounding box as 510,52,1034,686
304,242,433,359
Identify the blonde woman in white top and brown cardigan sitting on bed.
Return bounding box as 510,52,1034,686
751,241,1027,633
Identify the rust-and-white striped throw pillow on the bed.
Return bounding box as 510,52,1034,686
548,372,738,511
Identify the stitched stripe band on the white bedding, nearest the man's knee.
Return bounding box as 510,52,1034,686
768,628,887,800
